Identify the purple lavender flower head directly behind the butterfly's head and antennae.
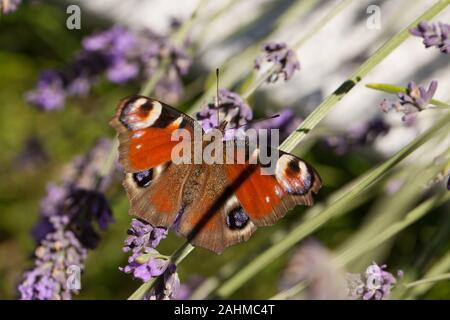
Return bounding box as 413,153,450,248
195,89,253,138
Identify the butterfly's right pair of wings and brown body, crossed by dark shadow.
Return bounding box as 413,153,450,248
176,146,321,253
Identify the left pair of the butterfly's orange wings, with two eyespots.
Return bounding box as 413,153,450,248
110,96,194,227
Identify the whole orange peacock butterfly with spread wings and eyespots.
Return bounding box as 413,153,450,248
111,96,321,253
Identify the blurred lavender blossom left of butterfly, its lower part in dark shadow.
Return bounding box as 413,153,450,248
33,139,113,248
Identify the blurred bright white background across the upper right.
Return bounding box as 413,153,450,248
67,0,450,156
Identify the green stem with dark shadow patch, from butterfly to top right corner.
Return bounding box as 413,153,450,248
280,0,450,152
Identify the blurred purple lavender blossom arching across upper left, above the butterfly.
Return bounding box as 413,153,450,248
26,26,192,111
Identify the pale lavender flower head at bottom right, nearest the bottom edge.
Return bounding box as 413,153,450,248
347,262,401,300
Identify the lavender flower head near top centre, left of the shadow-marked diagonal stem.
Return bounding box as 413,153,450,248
255,42,300,83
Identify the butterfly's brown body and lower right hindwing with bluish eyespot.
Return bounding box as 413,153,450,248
175,164,256,253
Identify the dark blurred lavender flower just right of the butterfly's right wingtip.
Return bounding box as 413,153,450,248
322,117,390,155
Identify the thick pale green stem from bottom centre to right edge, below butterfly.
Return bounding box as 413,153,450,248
213,114,450,297
